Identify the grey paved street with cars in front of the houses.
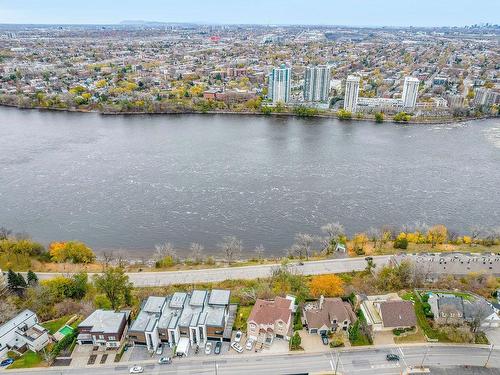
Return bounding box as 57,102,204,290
6,345,500,375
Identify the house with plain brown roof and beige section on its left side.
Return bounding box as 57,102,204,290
360,293,417,331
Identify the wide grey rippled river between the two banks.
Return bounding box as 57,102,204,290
0,108,500,254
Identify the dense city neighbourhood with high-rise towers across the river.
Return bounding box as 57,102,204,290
0,23,500,122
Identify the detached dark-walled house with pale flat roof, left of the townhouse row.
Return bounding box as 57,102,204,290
77,309,128,348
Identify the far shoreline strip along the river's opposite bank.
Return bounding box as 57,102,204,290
0,103,498,125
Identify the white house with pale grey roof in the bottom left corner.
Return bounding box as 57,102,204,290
0,310,49,358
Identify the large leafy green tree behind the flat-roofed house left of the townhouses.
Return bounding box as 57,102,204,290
94,267,132,310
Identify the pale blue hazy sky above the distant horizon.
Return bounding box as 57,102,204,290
0,0,500,26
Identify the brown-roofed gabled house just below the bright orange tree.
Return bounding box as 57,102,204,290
302,296,356,335
